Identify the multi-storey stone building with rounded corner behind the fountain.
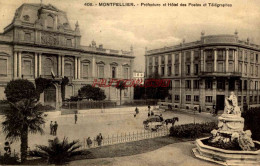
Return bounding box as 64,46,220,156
145,32,260,111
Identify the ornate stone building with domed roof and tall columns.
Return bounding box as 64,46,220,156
0,4,134,106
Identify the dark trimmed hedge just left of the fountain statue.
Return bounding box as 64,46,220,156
170,122,217,138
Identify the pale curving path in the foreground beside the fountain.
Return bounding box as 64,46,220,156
69,142,217,166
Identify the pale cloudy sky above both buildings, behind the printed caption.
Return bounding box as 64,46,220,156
0,0,260,71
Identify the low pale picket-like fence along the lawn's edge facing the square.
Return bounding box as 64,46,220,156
79,127,169,150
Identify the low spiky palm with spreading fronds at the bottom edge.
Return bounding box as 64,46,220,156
29,137,82,165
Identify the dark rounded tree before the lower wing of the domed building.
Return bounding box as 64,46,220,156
78,85,106,100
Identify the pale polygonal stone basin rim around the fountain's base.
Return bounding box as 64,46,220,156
192,137,260,166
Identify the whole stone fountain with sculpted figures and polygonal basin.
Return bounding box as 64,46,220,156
192,92,260,165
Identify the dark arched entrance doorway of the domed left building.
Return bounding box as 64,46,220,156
44,84,56,108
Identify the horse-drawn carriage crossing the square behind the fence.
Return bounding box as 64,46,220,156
143,115,179,131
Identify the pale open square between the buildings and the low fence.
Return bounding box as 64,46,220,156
0,107,216,155
